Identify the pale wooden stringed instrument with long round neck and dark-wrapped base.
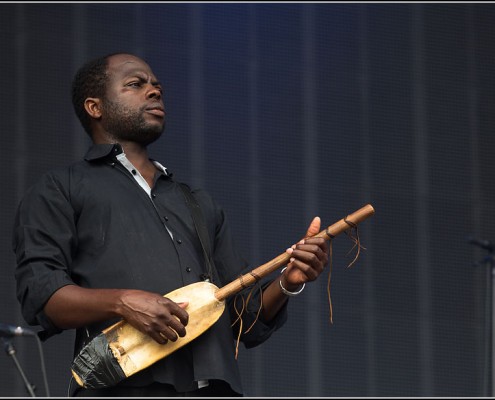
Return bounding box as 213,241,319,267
71,204,375,388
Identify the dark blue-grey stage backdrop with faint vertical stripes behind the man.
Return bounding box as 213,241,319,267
0,3,495,397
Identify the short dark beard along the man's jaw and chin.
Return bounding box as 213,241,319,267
102,99,165,146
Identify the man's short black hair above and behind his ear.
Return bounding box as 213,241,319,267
72,52,130,136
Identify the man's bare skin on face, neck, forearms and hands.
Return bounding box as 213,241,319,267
44,54,328,344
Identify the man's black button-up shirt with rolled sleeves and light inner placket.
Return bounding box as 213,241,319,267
13,144,287,393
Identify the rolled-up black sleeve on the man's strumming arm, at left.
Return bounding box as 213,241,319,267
12,170,76,339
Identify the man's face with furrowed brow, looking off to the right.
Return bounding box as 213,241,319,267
101,54,165,146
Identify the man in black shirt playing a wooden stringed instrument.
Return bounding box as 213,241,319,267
13,53,328,397
